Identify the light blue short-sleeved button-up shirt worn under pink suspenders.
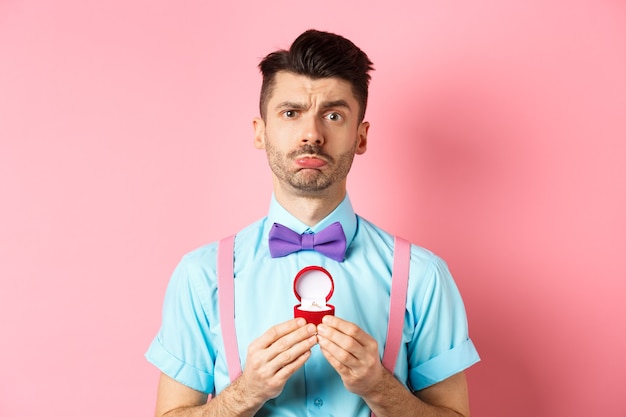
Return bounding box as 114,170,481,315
146,196,479,417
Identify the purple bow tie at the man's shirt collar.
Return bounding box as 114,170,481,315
269,222,346,262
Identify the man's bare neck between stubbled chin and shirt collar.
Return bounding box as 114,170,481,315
274,180,346,226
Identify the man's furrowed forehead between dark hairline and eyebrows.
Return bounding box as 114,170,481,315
268,71,358,106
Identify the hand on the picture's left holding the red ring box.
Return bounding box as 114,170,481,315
237,318,317,405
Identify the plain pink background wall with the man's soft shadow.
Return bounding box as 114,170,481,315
0,0,626,417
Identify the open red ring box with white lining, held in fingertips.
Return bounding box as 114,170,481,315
293,266,335,326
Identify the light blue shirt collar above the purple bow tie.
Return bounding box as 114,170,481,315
265,194,357,247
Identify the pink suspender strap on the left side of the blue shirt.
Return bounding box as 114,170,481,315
217,235,241,381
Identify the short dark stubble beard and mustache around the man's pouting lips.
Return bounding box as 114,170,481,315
265,136,356,194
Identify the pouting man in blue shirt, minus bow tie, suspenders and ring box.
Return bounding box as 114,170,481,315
146,30,479,417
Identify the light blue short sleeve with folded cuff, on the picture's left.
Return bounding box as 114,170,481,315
146,250,215,393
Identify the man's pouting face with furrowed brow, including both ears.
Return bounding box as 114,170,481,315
254,72,369,195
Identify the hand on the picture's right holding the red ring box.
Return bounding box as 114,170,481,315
317,316,386,397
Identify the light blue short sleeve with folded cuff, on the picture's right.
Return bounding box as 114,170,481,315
407,254,480,391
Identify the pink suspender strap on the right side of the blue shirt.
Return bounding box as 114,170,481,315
382,236,411,374
